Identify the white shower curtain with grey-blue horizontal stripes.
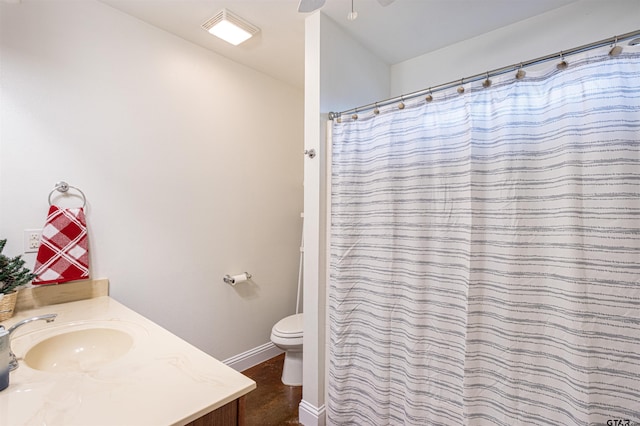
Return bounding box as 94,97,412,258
327,46,640,426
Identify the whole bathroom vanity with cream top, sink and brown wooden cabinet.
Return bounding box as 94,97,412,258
0,280,256,426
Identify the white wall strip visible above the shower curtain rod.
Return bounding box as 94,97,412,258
390,0,640,96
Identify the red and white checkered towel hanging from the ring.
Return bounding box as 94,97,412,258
33,206,89,284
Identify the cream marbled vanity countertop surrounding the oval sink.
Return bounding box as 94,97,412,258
0,296,256,426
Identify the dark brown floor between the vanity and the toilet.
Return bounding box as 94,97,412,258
242,354,302,426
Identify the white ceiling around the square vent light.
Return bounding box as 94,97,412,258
100,0,577,88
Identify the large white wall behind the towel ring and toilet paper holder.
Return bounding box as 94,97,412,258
0,0,303,359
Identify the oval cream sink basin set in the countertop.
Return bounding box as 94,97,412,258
24,328,133,372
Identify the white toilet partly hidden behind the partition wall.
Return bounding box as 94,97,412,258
271,314,303,386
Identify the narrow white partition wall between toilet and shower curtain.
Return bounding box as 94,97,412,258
300,12,389,425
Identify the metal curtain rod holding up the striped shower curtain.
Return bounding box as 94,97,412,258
329,30,640,120
